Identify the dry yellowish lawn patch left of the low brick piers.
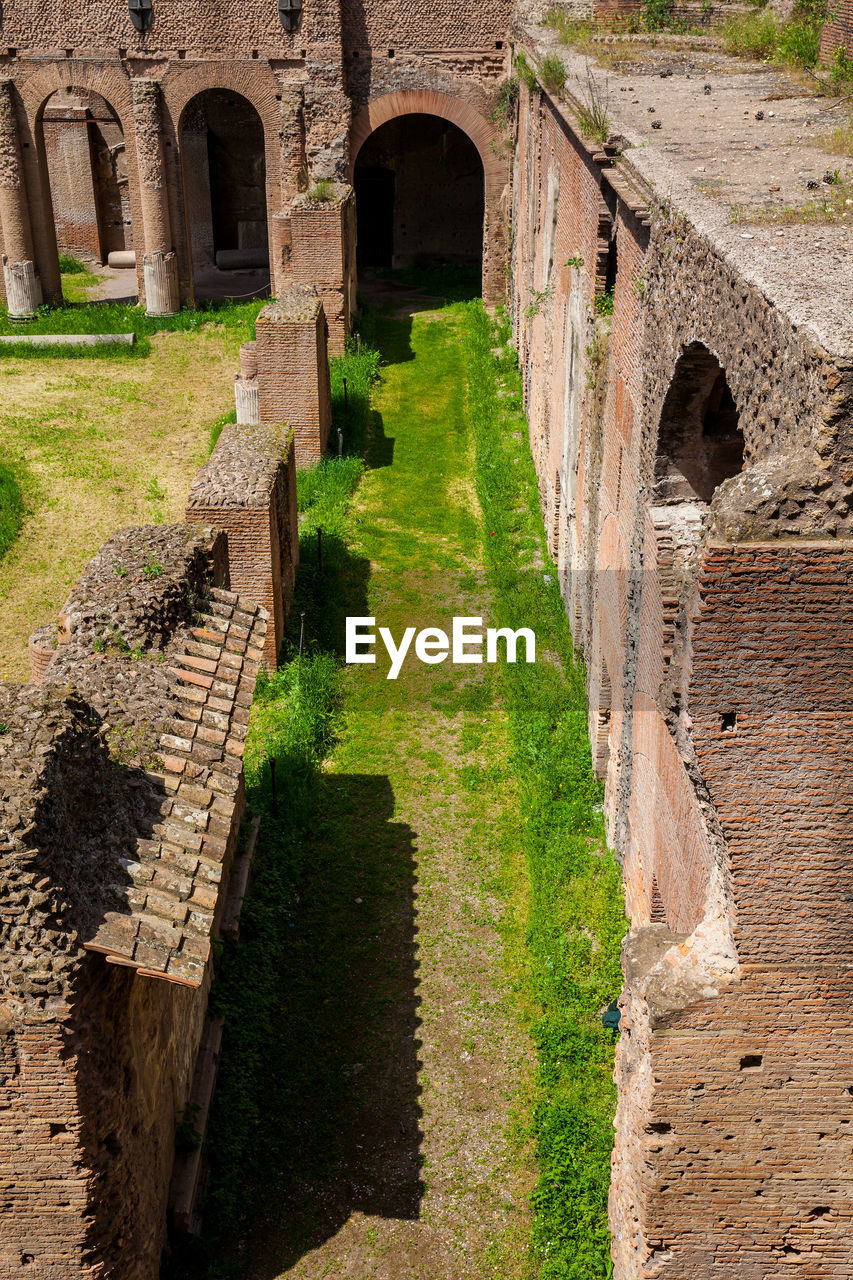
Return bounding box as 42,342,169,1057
0,320,254,680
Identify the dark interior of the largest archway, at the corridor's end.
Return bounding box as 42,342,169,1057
355,113,484,285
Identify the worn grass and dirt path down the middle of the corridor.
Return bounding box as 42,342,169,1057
240,304,532,1280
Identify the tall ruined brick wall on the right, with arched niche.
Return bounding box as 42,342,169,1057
512,72,853,1280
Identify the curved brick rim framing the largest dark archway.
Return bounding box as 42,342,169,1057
347,90,508,302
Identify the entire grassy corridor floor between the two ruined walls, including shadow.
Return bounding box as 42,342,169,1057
167,293,624,1280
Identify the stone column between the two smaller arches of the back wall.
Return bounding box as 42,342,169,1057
131,79,175,316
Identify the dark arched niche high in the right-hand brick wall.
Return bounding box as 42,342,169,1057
653,342,744,506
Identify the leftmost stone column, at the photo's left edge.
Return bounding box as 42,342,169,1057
0,81,41,319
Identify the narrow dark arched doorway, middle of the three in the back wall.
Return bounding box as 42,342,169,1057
181,88,269,300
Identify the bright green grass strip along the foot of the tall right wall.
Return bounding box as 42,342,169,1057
466,305,628,1280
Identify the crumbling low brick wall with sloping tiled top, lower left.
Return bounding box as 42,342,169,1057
0,525,266,1280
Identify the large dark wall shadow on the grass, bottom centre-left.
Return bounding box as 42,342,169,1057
243,774,423,1280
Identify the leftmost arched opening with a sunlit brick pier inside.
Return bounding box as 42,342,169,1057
42,87,136,272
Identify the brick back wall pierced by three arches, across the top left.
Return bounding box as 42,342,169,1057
0,0,511,309
